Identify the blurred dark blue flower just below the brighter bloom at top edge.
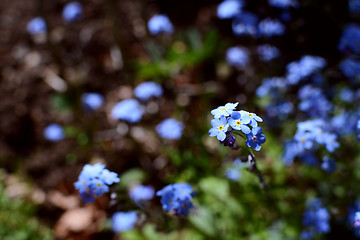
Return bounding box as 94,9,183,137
231,12,258,37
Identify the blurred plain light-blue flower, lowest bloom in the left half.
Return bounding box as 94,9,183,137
111,211,138,233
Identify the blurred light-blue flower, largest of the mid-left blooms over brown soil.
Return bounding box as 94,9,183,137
111,98,145,123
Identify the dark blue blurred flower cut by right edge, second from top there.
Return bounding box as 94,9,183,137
338,23,360,54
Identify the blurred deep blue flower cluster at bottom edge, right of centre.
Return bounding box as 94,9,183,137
300,199,330,239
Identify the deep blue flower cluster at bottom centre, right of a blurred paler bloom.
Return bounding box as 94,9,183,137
156,183,195,216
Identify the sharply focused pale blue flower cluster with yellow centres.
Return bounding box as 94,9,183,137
209,103,266,151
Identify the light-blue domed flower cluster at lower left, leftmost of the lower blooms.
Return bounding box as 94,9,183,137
74,163,120,203
